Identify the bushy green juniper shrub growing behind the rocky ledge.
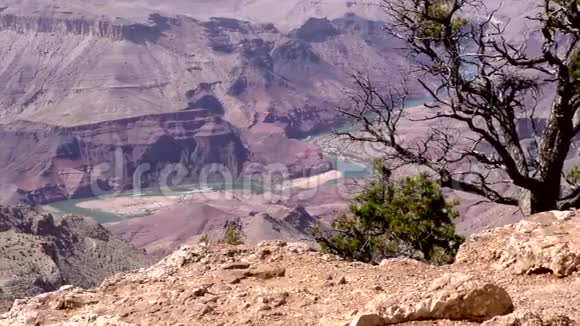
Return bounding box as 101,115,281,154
313,161,464,264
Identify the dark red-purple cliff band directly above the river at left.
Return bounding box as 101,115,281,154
0,110,249,204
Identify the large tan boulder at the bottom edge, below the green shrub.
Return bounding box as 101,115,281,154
361,274,514,324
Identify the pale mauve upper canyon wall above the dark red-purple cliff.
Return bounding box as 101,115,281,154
0,9,420,138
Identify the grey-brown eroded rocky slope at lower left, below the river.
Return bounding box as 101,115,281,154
0,207,152,310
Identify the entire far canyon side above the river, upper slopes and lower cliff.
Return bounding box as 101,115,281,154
0,1,420,204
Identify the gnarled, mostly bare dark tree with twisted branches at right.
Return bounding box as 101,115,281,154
339,0,580,213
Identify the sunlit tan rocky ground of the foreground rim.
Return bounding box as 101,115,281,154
0,212,580,326
